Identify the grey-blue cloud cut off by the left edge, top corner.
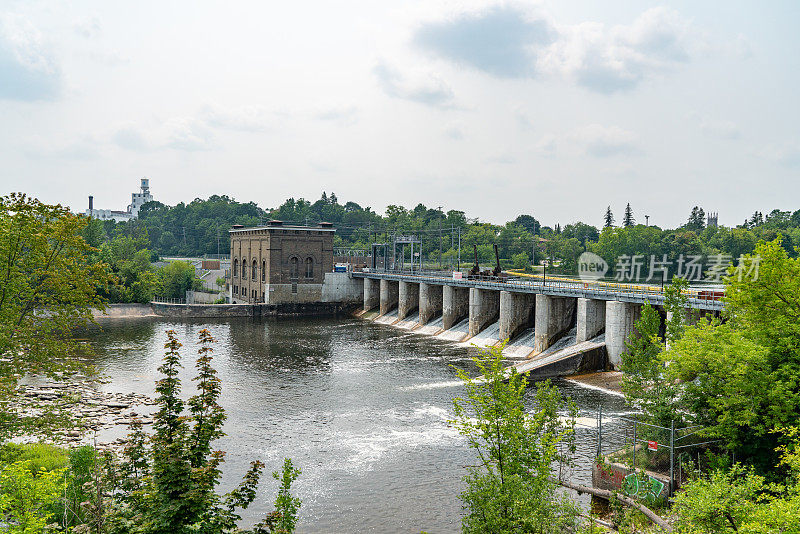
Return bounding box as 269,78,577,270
0,15,61,101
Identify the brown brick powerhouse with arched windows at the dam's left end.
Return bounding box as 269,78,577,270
229,221,336,304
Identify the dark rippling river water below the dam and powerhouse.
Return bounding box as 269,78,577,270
88,318,625,533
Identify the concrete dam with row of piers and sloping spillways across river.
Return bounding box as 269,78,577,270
351,272,723,379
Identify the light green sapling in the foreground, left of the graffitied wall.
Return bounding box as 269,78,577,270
453,347,578,533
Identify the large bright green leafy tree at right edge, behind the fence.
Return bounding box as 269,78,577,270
664,240,800,472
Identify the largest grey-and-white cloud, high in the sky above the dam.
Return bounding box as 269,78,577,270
413,6,698,94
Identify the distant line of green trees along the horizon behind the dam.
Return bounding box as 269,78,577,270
92,192,800,274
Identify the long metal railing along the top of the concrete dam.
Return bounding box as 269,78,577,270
352,270,725,311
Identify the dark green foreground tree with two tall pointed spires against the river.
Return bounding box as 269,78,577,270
109,330,300,534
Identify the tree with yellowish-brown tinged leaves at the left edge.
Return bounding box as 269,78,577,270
0,194,110,441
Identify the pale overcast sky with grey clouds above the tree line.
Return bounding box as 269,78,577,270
0,0,800,227
